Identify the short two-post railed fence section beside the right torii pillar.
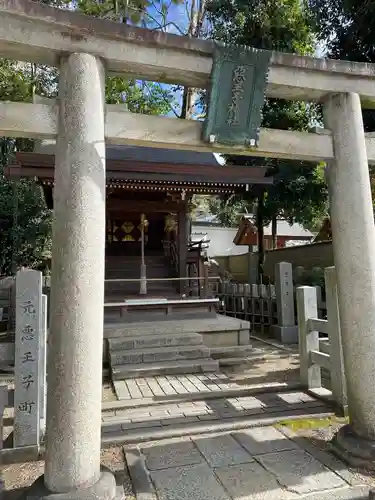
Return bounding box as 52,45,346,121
297,267,347,413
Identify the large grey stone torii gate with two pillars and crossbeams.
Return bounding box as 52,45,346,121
0,0,375,499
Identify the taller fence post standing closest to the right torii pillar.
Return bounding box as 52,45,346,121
324,267,348,414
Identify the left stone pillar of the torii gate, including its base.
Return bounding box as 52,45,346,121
23,54,116,500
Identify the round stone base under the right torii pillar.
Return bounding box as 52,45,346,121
330,425,375,470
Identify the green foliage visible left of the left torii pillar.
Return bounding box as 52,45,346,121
0,60,54,274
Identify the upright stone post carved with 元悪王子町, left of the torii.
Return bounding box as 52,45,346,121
14,269,42,447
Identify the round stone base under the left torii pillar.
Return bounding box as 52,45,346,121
18,470,125,500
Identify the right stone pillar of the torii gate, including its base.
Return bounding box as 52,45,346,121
324,93,375,466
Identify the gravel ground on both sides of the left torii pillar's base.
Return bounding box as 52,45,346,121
2,447,135,500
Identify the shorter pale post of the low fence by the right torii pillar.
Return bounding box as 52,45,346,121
296,286,322,389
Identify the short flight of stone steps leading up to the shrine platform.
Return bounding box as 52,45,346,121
108,332,219,381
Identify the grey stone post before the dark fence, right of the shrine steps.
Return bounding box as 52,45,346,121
272,262,298,344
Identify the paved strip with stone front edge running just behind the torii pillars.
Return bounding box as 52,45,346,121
102,391,333,445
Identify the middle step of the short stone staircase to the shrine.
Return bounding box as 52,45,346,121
109,345,210,366
